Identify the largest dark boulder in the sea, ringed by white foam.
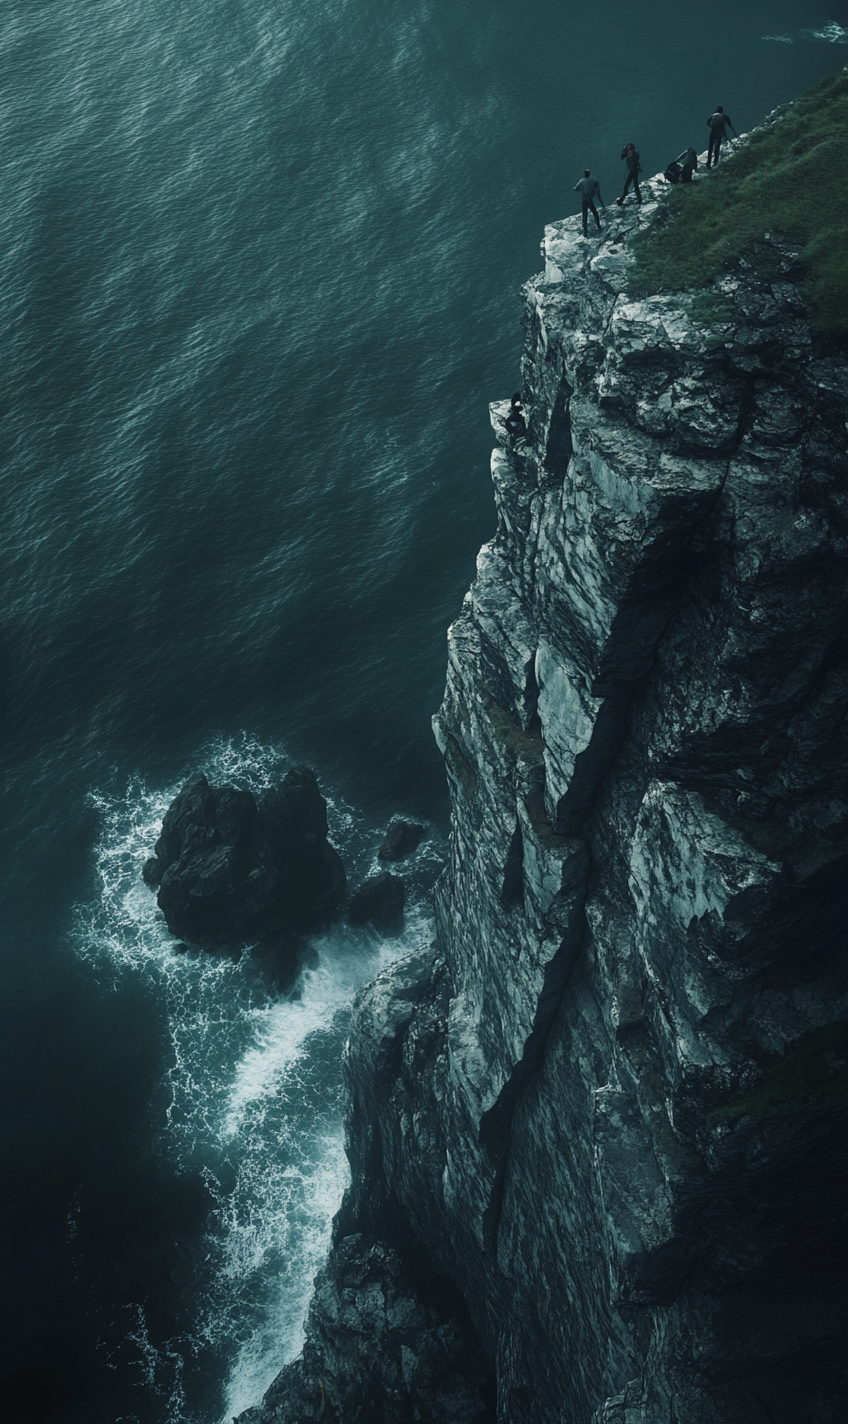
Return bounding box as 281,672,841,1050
144,766,344,946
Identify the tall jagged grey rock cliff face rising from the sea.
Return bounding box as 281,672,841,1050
239,169,848,1424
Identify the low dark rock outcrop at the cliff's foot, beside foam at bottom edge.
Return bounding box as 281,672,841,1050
239,1235,494,1424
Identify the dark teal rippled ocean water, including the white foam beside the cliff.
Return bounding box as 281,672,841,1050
0,0,848,1424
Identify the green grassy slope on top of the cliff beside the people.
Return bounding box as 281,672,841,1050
630,70,848,332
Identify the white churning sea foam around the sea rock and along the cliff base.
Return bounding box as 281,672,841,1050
77,738,438,1424
